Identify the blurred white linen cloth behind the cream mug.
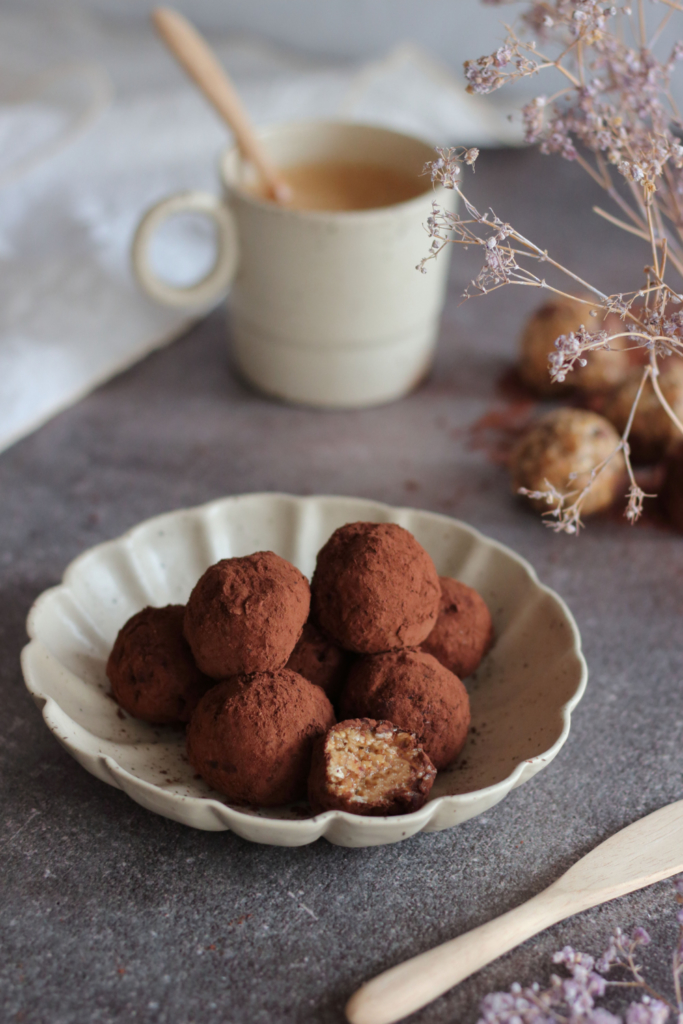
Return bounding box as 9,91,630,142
0,14,518,451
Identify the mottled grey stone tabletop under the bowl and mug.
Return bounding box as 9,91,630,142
0,153,683,1024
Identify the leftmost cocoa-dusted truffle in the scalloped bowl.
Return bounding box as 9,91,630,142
106,604,209,725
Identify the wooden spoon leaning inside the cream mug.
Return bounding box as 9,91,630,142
152,7,291,205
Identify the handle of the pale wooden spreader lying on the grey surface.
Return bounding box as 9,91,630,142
346,887,574,1024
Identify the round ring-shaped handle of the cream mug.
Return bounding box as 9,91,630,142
131,191,240,309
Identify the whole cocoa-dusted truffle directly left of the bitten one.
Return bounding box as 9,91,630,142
187,669,335,807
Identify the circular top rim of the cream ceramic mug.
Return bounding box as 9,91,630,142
218,118,446,222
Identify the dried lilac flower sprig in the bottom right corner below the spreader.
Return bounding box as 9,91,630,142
478,877,683,1024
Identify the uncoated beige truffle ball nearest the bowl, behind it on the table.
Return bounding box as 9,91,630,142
510,409,626,515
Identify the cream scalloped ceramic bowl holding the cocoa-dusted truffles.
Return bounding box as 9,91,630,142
22,494,587,847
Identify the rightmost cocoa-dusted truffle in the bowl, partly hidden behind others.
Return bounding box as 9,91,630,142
421,577,494,679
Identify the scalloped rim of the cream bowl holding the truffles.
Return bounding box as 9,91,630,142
20,492,588,845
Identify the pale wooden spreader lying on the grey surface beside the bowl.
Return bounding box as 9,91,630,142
346,800,683,1024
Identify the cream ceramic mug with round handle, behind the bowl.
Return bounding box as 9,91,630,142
133,121,456,409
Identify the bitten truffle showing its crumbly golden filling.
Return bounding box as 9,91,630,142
308,718,436,816
